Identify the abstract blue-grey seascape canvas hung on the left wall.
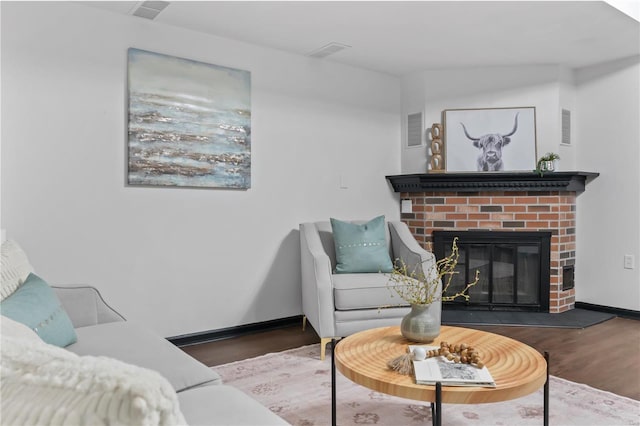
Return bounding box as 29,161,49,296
128,48,251,189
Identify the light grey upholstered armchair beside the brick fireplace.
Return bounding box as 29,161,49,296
300,221,435,359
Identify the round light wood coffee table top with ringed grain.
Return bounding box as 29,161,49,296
334,326,547,404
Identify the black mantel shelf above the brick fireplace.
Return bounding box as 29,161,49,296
386,172,600,192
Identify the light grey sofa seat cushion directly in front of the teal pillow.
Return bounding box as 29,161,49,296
67,321,222,392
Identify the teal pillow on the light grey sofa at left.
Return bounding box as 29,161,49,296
0,273,78,347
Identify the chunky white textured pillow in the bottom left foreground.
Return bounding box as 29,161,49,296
0,333,186,425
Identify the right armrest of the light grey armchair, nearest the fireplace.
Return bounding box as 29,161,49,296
389,221,438,288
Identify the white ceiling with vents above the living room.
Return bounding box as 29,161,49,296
83,1,640,76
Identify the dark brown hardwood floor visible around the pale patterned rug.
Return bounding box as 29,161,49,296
182,318,640,400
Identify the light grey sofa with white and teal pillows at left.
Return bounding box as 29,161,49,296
0,241,288,426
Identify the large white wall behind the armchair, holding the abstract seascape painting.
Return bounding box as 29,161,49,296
1,2,401,336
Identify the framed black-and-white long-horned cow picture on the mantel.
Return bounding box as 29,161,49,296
442,107,537,172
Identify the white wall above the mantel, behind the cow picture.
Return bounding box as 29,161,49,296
402,65,567,173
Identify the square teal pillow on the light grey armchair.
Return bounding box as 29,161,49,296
331,216,393,274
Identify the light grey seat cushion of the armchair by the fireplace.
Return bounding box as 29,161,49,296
332,274,407,311
